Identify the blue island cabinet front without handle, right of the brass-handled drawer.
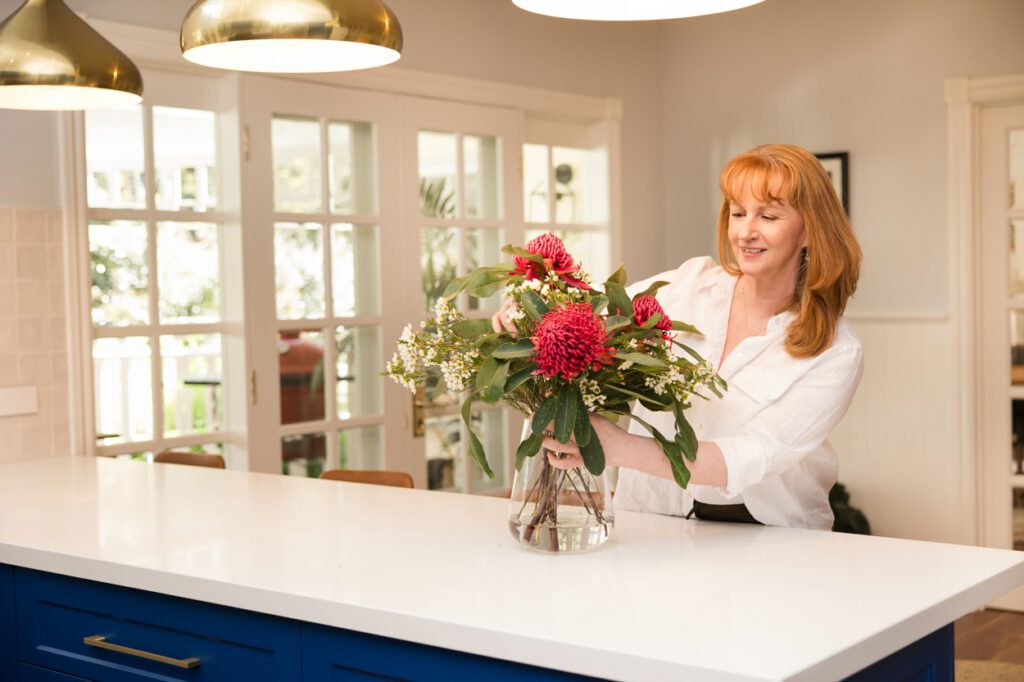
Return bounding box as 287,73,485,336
302,624,594,682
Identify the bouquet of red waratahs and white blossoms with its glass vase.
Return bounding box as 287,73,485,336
387,233,725,551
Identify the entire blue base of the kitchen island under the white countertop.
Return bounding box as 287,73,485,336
0,564,953,682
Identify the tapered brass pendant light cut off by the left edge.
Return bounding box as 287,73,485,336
0,0,142,111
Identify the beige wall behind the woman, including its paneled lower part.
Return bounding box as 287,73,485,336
662,0,1024,542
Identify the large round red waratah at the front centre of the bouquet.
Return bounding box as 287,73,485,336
530,303,615,381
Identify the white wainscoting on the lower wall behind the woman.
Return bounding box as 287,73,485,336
831,314,962,544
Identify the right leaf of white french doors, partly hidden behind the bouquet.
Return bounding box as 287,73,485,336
399,97,524,494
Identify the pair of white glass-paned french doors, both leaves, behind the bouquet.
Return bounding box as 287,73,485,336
240,76,523,485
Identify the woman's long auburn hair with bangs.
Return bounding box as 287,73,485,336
718,144,862,357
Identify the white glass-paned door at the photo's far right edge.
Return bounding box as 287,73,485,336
979,105,1024,610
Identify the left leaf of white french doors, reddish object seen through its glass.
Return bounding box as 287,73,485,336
240,76,413,477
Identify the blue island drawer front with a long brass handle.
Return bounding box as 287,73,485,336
14,568,302,682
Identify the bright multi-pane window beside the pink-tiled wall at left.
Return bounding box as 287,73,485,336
84,84,238,456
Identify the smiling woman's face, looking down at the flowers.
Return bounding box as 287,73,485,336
729,179,807,286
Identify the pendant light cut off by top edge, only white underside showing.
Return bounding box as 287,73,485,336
512,0,764,22
